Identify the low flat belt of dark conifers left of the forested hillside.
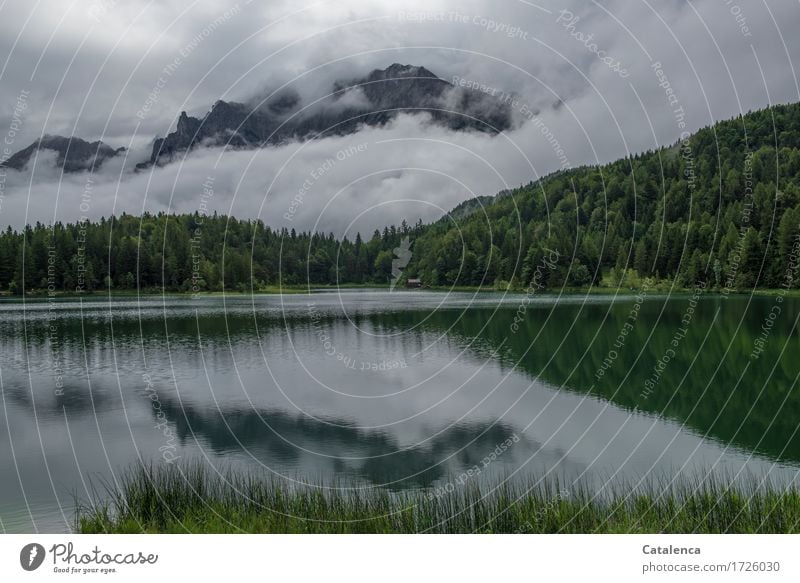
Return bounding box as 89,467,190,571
0,214,422,293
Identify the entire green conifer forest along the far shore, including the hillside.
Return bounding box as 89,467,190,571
0,104,800,294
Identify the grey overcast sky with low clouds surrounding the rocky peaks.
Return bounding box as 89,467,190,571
0,0,800,234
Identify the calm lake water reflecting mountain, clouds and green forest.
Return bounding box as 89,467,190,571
0,290,800,532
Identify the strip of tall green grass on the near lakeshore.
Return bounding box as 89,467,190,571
77,466,800,533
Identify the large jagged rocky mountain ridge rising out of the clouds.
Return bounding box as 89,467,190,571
137,64,511,169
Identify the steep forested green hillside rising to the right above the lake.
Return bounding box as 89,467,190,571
407,104,800,291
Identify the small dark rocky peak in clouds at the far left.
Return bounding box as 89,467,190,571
0,136,125,172
